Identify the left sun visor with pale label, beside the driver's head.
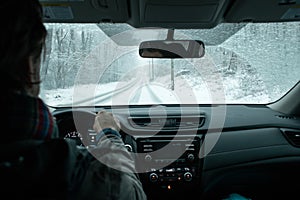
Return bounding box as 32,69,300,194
40,0,129,23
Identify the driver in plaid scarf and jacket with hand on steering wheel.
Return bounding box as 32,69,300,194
0,0,146,200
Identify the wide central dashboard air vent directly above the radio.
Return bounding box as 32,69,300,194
128,115,205,130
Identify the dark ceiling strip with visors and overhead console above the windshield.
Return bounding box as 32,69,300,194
40,0,300,29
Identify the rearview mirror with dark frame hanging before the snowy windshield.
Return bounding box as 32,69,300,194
139,40,205,58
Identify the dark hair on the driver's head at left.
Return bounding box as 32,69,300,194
0,0,47,91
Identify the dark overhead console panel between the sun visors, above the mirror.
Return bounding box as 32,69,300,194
130,0,228,29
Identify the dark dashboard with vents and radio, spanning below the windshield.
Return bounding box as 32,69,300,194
53,105,300,199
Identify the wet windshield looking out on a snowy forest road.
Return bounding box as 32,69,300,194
40,22,300,107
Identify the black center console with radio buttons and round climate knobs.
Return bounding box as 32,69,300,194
136,135,202,199
